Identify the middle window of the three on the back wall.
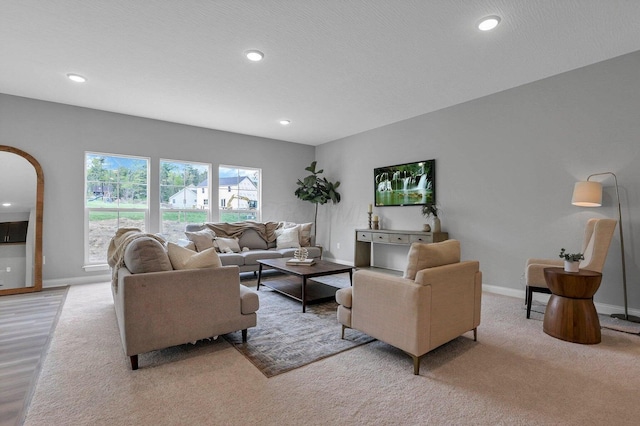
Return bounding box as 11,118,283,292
160,160,211,242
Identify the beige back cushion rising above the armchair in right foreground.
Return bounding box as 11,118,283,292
403,240,460,280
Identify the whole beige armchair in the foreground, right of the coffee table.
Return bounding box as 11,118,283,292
336,240,482,374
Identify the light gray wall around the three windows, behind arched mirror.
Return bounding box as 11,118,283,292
0,94,315,286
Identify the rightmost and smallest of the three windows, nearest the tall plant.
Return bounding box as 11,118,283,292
218,166,261,222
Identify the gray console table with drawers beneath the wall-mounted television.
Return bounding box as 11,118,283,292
353,229,449,268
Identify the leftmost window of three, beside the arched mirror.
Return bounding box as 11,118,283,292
84,152,149,265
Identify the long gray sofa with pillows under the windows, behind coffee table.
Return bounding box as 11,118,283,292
181,221,322,272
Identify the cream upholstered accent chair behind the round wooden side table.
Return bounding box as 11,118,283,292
524,219,618,318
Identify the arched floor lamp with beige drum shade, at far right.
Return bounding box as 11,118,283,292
571,172,640,323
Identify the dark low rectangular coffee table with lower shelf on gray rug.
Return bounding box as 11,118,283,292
257,259,353,312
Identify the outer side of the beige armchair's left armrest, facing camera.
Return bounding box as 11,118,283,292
351,270,431,356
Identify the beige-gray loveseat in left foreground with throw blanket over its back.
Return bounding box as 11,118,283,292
109,230,259,370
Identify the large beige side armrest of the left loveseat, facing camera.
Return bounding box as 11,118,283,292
114,266,242,355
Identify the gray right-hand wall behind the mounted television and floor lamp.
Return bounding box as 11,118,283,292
316,52,640,309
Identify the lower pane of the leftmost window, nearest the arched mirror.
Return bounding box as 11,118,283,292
88,210,146,263
